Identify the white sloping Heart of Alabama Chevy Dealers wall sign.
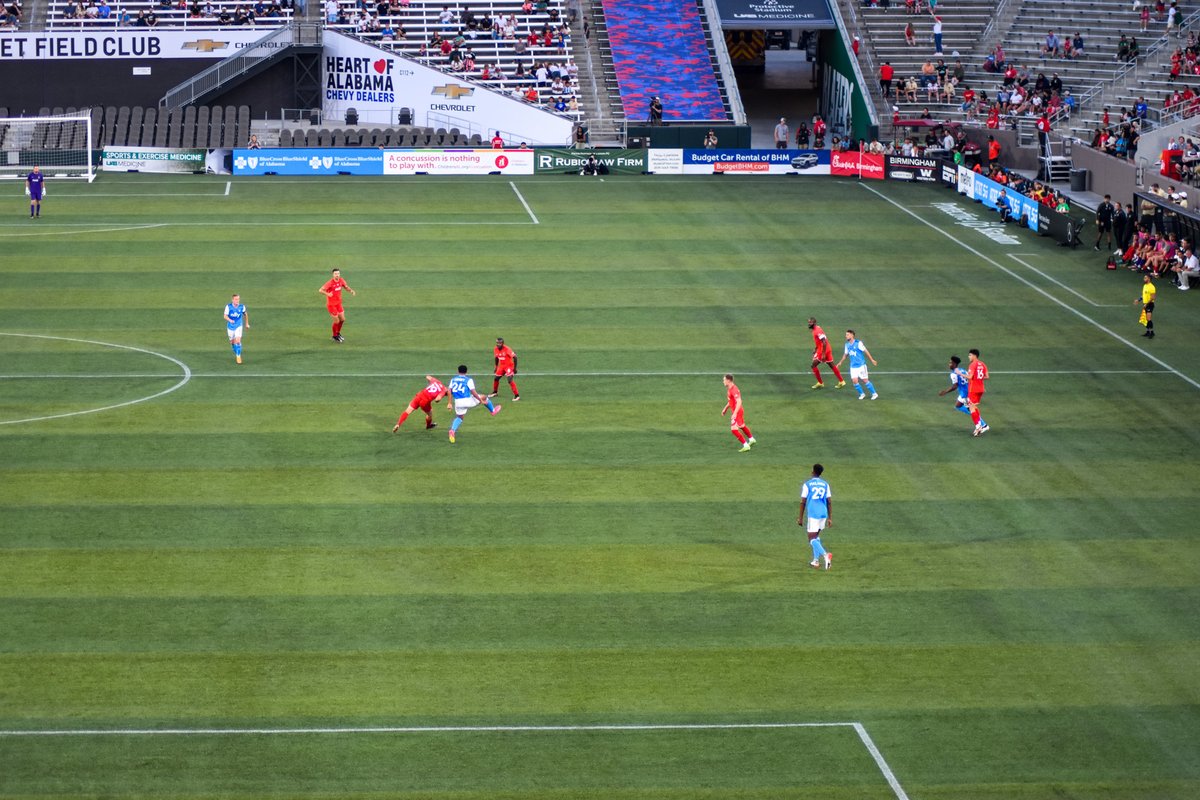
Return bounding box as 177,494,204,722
322,30,574,145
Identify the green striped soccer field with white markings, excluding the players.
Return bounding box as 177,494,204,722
0,175,1200,800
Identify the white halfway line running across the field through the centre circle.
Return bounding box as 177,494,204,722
0,369,1175,380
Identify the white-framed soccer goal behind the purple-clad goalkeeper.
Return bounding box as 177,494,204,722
0,109,96,182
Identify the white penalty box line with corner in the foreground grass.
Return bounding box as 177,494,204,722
0,722,908,800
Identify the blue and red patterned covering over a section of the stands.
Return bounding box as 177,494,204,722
601,0,733,122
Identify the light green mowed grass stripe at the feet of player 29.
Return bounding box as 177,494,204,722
0,542,1200,599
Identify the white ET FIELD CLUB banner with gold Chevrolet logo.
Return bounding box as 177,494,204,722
0,28,274,61
